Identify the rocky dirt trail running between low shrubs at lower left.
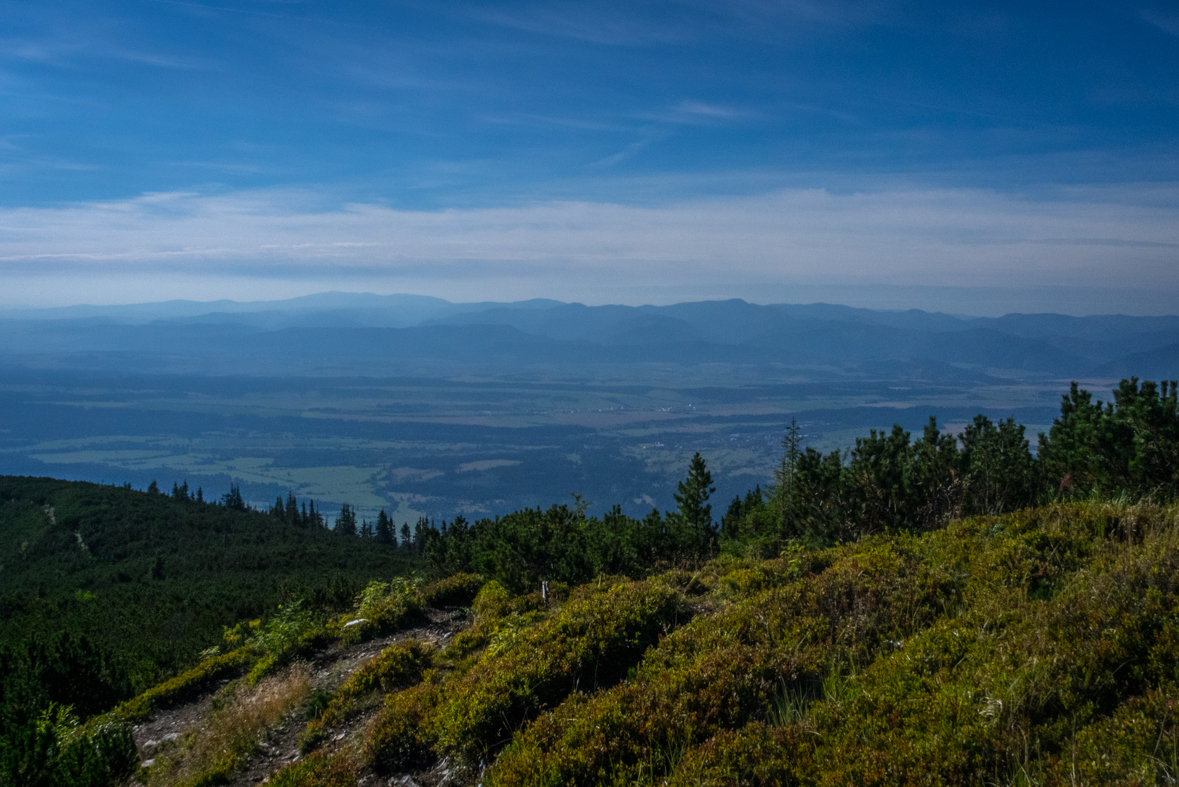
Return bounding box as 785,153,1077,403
131,609,469,787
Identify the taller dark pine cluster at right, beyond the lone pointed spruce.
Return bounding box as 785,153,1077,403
722,378,1179,553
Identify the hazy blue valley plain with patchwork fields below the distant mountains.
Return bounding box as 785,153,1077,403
0,364,1070,522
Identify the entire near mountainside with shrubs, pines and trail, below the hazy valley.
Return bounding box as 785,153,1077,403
0,379,1179,786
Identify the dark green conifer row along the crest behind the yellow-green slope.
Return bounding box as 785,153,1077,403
415,378,1179,590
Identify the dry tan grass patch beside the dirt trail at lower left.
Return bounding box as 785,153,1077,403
147,663,311,787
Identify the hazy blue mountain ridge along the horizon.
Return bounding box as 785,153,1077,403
0,292,1179,377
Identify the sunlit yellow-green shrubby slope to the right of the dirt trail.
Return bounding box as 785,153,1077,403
244,503,1179,787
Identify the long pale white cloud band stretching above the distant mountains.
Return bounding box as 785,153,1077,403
0,189,1179,292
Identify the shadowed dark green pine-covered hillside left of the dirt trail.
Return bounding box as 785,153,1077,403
0,477,416,783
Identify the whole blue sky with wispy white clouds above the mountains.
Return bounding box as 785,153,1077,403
0,0,1179,315
